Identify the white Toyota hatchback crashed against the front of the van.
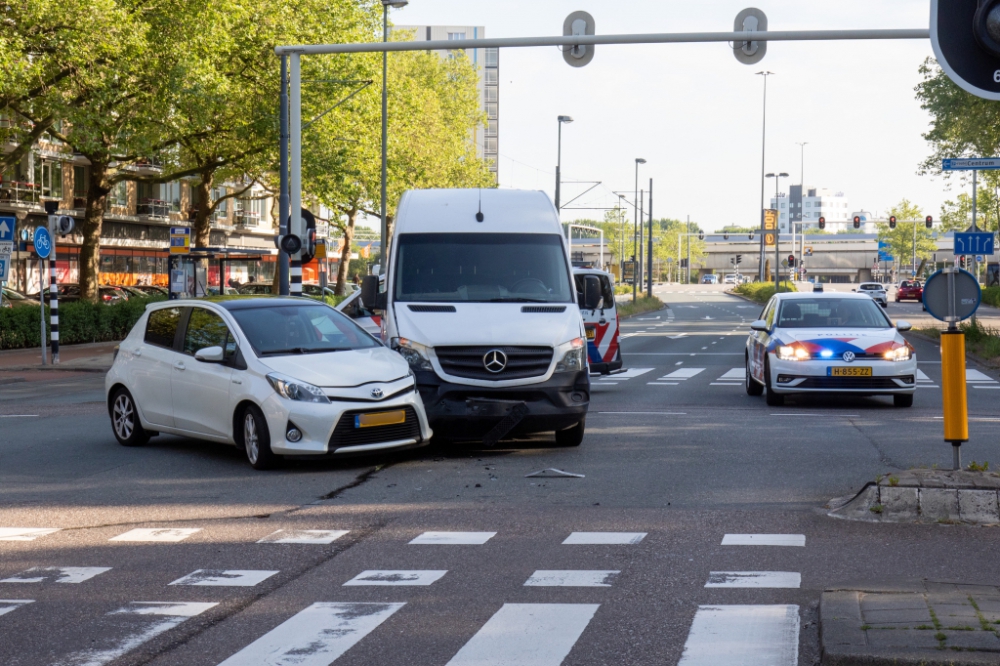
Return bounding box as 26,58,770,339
105,298,432,469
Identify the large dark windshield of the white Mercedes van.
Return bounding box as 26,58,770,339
393,234,573,303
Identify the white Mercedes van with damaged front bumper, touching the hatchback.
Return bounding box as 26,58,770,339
362,190,601,446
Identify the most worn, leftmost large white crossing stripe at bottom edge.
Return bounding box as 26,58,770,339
57,601,218,666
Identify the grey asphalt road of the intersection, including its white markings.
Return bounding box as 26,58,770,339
0,286,1000,666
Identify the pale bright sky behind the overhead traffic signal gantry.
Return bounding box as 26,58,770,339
380,0,963,230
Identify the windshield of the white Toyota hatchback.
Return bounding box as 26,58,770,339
231,304,379,356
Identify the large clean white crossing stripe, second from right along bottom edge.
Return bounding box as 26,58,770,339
447,604,600,666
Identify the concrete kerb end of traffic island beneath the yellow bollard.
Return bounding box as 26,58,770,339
827,470,1000,525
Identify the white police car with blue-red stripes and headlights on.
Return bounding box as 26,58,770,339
746,293,917,407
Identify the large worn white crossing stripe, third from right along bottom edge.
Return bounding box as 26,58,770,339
219,603,406,666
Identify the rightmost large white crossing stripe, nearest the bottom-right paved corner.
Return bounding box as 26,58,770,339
678,606,799,666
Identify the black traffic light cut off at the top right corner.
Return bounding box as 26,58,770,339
931,0,1000,100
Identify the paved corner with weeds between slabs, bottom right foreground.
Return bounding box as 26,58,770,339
820,581,1000,666
